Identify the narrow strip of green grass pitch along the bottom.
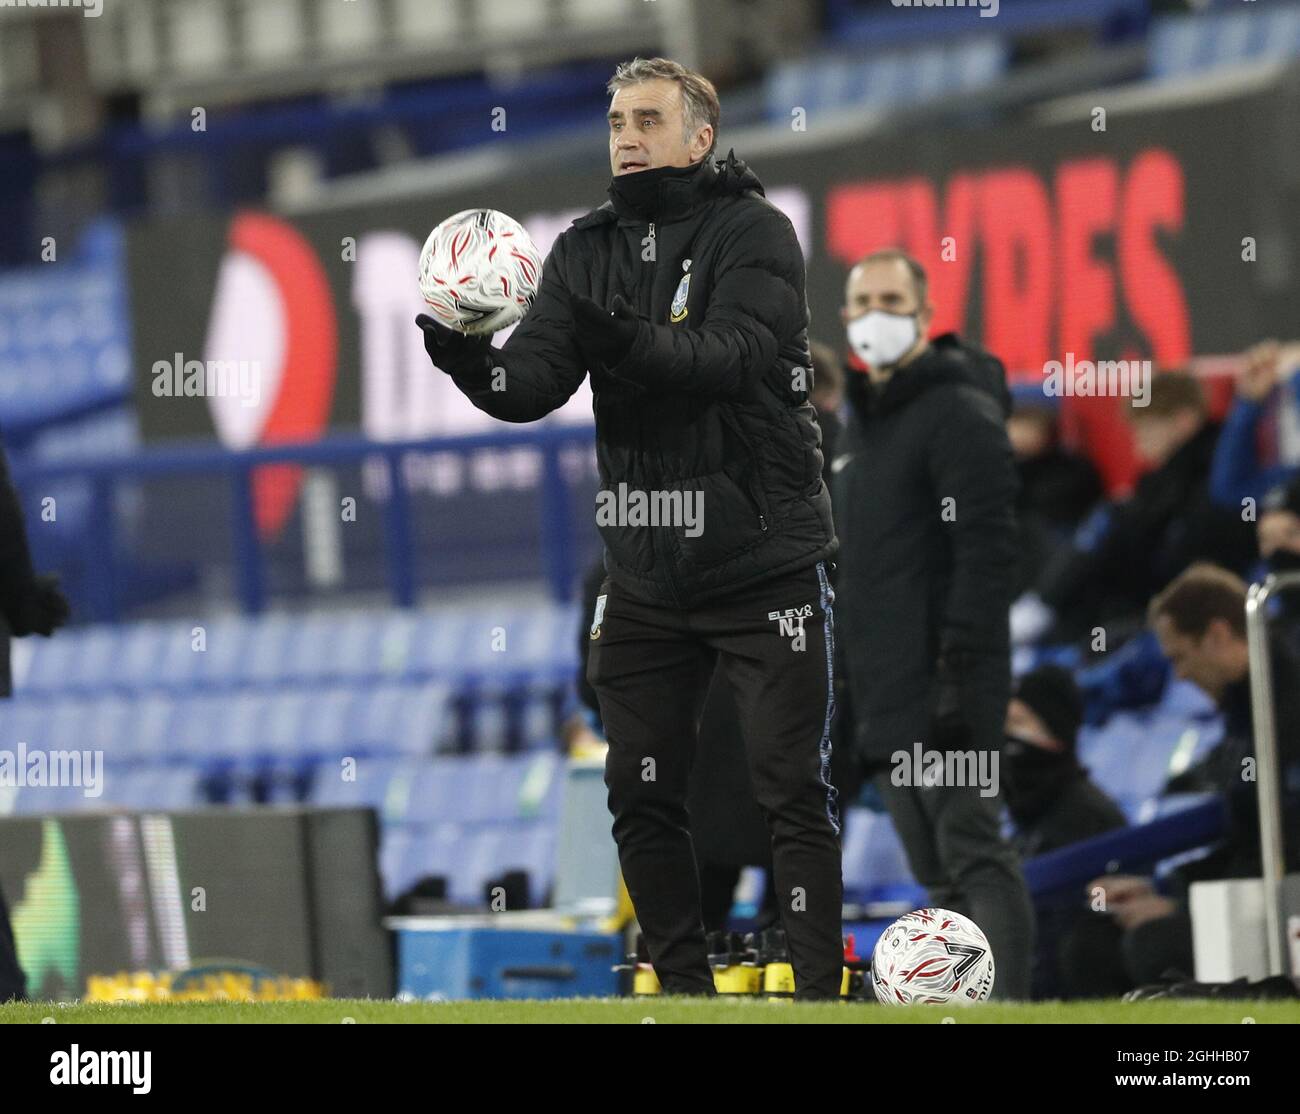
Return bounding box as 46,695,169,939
0,998,1300,1026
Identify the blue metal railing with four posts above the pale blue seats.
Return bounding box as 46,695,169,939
13,425,594,621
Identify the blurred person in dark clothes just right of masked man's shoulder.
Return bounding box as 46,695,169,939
1006,403,1101,595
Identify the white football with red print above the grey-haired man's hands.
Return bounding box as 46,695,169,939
420,209,542,337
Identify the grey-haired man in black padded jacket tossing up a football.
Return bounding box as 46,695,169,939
419,58,842,998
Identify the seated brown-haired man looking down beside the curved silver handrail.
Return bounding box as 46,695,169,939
1060,564,1300,997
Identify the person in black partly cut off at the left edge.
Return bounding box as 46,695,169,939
0,428,69,1002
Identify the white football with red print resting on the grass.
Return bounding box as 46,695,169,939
871,909,993,1006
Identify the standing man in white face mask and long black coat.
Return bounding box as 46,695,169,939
832,250,1034,998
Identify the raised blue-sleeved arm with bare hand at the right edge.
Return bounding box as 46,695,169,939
1210,341,1300,512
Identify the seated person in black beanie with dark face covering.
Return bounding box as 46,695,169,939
1002,666,1128,858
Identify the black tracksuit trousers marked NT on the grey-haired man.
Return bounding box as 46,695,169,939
588,562,844,998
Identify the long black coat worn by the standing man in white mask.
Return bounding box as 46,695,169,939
832,333,1017,764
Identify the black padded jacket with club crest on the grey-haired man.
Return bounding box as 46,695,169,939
445,152,836,607
